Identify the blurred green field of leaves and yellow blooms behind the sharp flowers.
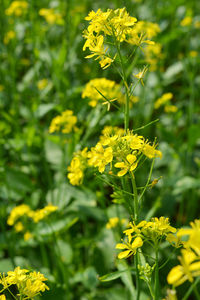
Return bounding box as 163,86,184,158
0,0,200,300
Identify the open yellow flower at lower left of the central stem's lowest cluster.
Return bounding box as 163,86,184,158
115,237,143,259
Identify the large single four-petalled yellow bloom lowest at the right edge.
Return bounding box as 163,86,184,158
167,249,200,287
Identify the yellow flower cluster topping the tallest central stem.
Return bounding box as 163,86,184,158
83,8,160,69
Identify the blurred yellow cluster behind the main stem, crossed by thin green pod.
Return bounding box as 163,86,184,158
82,78,138,107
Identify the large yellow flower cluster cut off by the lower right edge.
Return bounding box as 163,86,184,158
167,220,200,287
